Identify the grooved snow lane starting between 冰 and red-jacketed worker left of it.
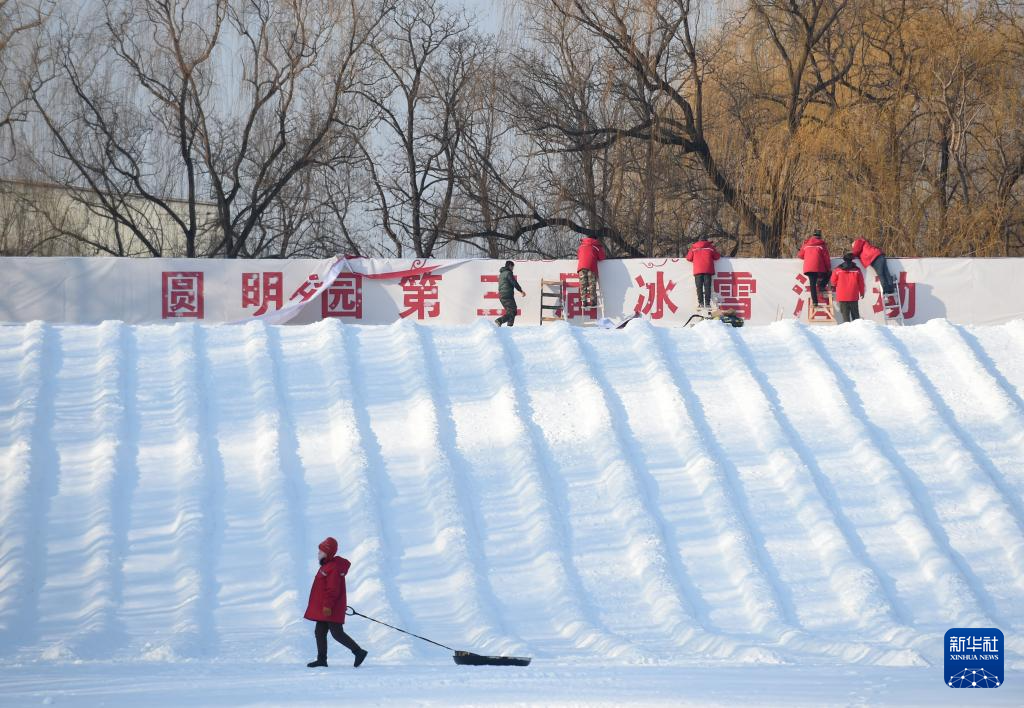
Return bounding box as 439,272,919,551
579,323,782,663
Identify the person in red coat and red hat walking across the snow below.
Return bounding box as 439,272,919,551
305,536,368,668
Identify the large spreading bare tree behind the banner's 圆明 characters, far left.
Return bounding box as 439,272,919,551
24,0,391,258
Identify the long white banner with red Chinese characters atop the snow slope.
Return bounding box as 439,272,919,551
0,258,1024,325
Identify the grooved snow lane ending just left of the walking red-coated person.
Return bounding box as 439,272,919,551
206,323,302,661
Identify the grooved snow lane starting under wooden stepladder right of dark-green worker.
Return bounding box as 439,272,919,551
515,324,704,656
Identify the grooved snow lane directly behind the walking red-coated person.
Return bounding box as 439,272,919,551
274,320,412,662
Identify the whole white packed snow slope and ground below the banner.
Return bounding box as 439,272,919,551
0,321,1024,705
